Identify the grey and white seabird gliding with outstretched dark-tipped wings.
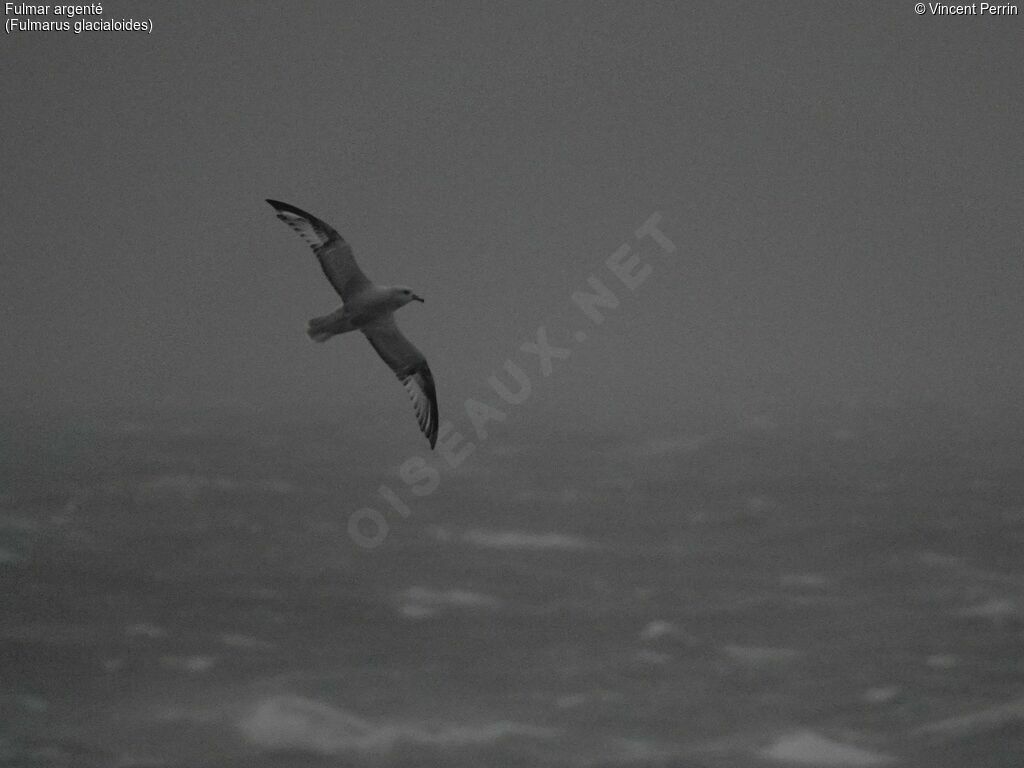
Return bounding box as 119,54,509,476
266,200,437,449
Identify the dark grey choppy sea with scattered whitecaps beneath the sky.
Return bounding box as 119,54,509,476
0,408,1024,768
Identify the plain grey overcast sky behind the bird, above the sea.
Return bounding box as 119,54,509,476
0,1,1024,439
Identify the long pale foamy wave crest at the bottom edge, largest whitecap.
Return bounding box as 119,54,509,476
238,694,554,755
